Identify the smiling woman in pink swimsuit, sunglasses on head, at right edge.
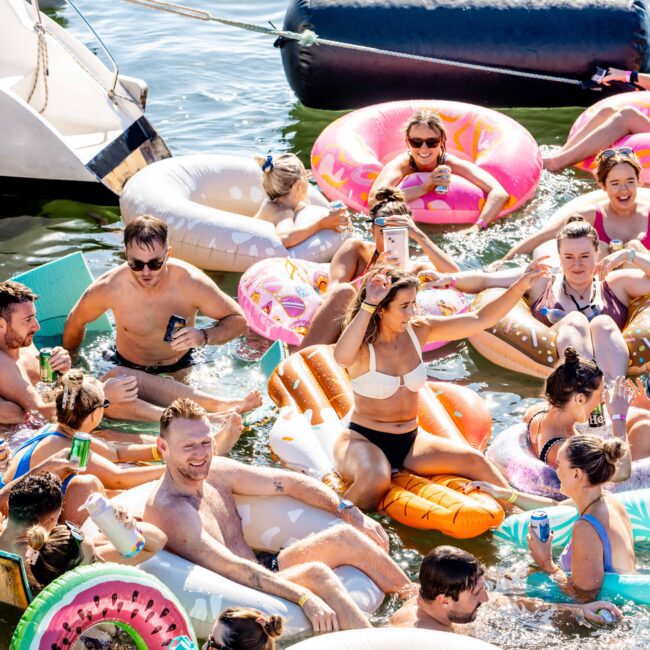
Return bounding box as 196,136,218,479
504,147,650,259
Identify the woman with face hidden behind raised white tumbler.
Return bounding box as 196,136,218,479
300,187,459,348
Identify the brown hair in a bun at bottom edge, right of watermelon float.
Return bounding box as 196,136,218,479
219,607,284,650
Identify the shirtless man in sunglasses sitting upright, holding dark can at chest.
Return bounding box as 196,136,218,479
63,216,261,413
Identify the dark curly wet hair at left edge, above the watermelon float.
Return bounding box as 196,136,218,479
8,472,63,526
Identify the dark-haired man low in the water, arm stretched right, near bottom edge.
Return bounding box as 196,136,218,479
389,546,621,634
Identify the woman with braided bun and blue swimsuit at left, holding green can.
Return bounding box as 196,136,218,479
2,368,165,522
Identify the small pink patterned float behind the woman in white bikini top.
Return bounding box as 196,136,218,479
237,257,469,351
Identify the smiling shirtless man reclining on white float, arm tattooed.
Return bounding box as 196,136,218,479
144,399,413,632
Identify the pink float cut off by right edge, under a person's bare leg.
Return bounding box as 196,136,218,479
569,91,650,185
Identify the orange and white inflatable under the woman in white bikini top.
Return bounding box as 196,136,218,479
268,345,504,538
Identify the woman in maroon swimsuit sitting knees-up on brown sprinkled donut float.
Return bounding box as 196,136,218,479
429,216,650,381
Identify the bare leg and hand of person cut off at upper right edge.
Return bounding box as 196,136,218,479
542,68,650,172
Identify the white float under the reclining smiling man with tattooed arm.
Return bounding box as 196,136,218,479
83,482,384,639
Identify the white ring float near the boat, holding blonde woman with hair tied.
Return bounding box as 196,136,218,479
120,154,347,272
